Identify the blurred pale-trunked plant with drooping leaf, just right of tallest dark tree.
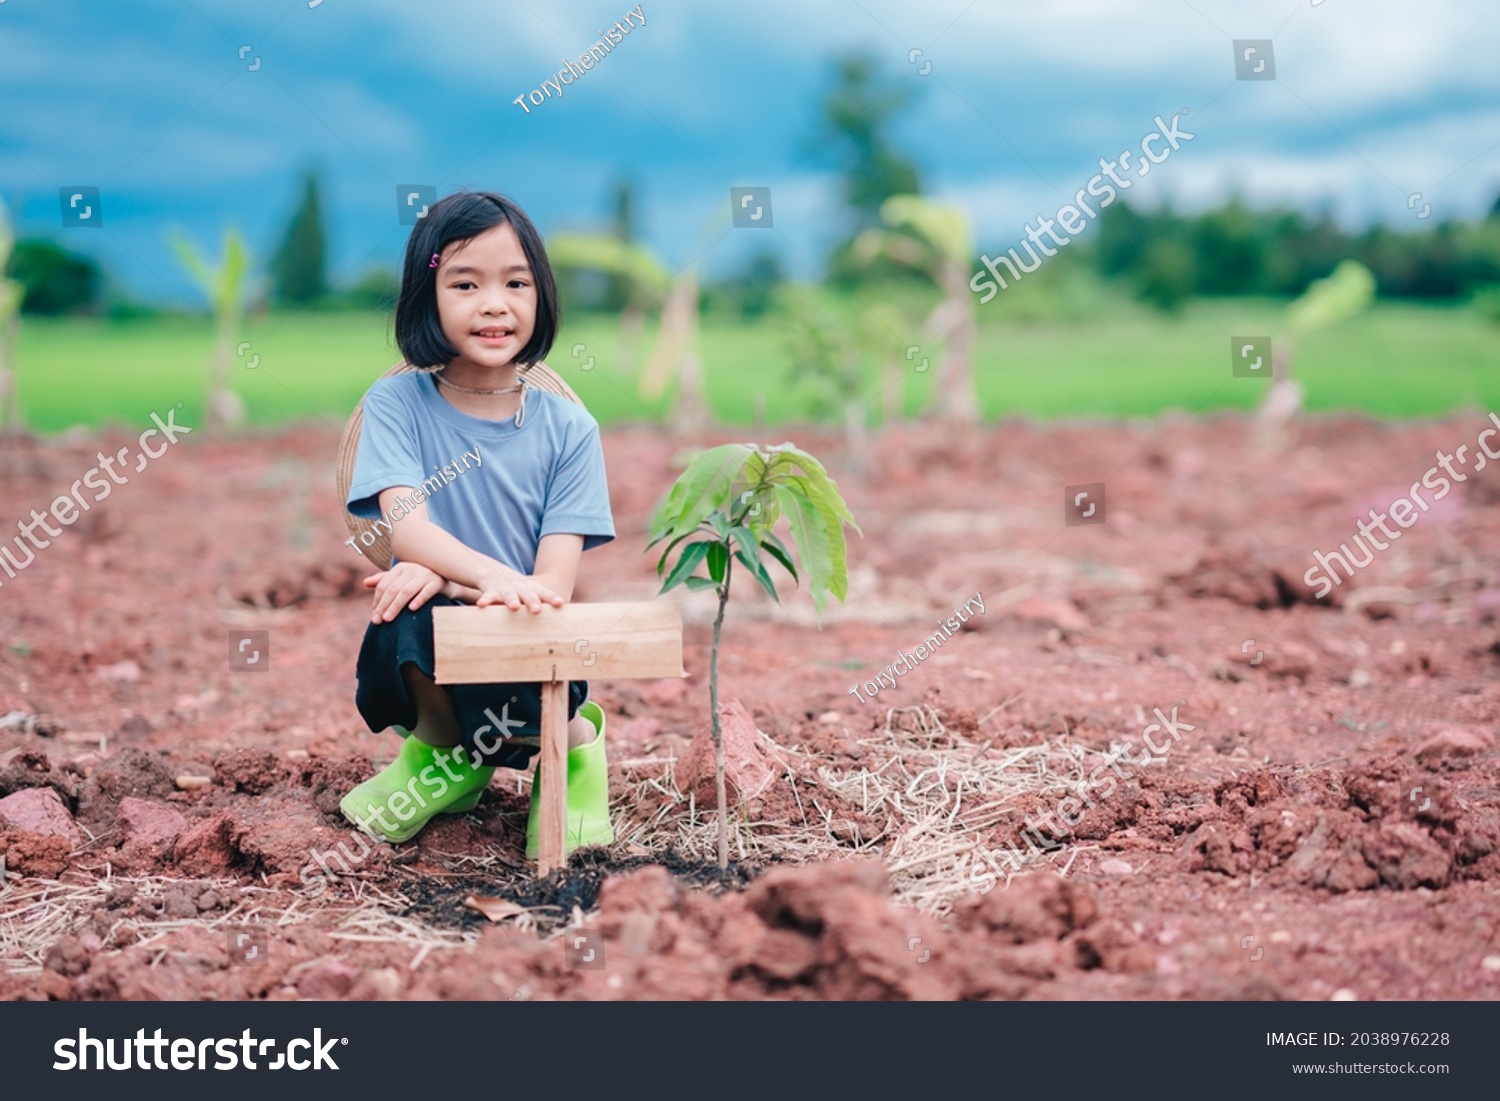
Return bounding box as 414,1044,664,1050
852,195,980,425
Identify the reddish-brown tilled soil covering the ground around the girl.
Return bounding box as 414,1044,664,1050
0,416,1500,999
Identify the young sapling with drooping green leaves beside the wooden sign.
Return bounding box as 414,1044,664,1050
647,443,863,869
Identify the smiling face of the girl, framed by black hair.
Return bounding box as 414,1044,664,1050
438,222,537,369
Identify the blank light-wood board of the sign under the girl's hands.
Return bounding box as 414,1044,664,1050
432,600,687,684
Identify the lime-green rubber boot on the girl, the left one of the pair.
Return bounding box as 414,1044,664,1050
339,737,495,845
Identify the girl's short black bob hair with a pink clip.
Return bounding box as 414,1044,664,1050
396,191,563,368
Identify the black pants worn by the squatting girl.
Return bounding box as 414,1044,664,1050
354,596,588,768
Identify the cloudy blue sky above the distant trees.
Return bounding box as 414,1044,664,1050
0,0,1500,303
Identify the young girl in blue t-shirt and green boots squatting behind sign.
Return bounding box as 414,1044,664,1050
339,192,615,857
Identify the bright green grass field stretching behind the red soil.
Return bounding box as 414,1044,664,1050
17,299,1500,434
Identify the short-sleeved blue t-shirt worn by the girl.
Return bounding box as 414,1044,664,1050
347,372,615,575
